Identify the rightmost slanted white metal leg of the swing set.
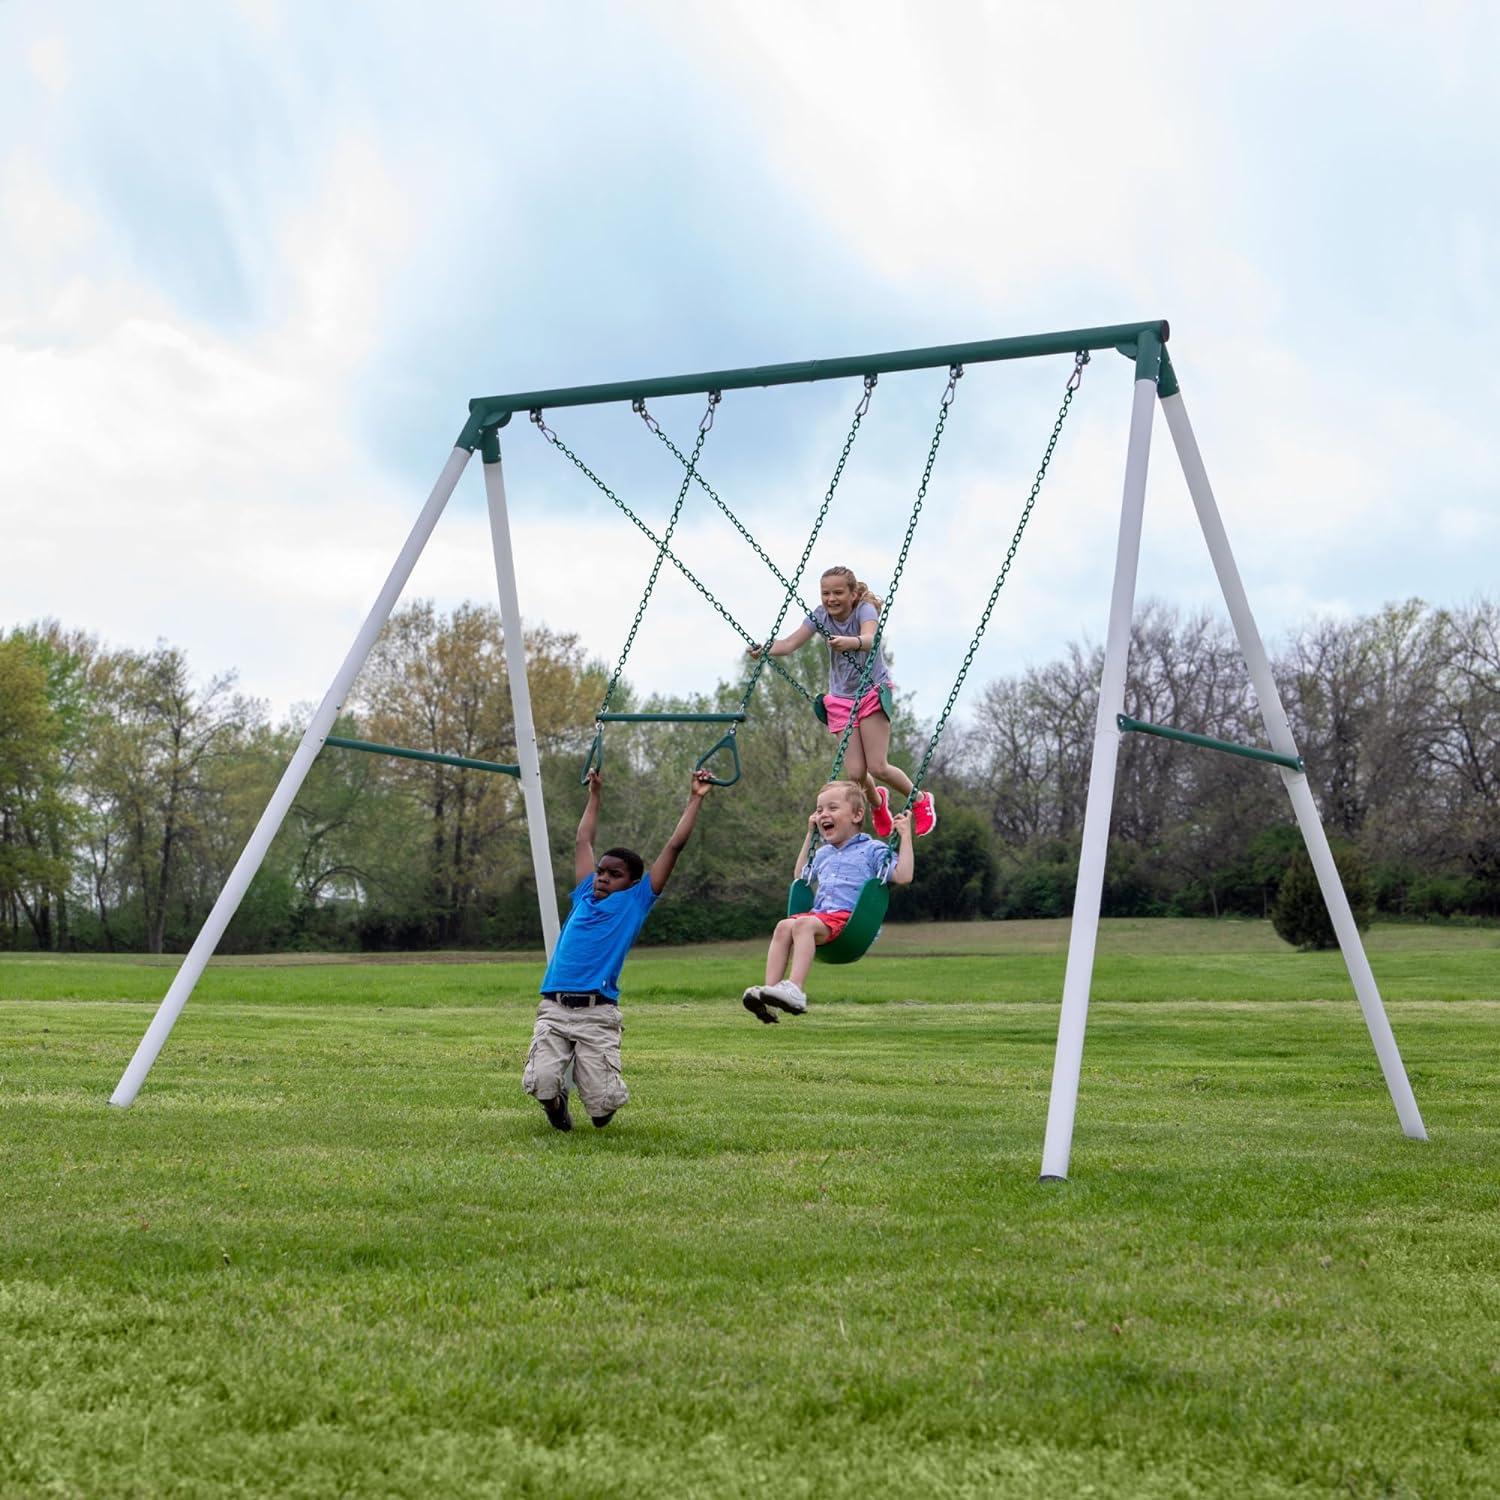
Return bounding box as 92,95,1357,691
1161,393,1427,1140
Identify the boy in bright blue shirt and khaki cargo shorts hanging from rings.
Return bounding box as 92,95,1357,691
521,771,713,1130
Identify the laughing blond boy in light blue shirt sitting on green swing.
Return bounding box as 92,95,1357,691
744,782,915,1026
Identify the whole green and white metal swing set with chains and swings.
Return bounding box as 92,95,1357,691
110,321,1427,1181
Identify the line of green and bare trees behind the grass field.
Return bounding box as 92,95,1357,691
0,600,1500,953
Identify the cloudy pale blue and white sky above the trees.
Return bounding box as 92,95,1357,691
0,0,1500,738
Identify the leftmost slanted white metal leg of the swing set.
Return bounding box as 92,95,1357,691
110,449,470,1107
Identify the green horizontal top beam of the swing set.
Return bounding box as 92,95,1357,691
458,318,1169,453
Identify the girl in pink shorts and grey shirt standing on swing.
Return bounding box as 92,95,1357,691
747,567,938,839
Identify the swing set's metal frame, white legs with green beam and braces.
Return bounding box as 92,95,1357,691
110,320,1427,1182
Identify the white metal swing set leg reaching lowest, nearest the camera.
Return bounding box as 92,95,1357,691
1041,380,1157,1182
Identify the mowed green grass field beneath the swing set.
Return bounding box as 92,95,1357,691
0,923,1500,1500
